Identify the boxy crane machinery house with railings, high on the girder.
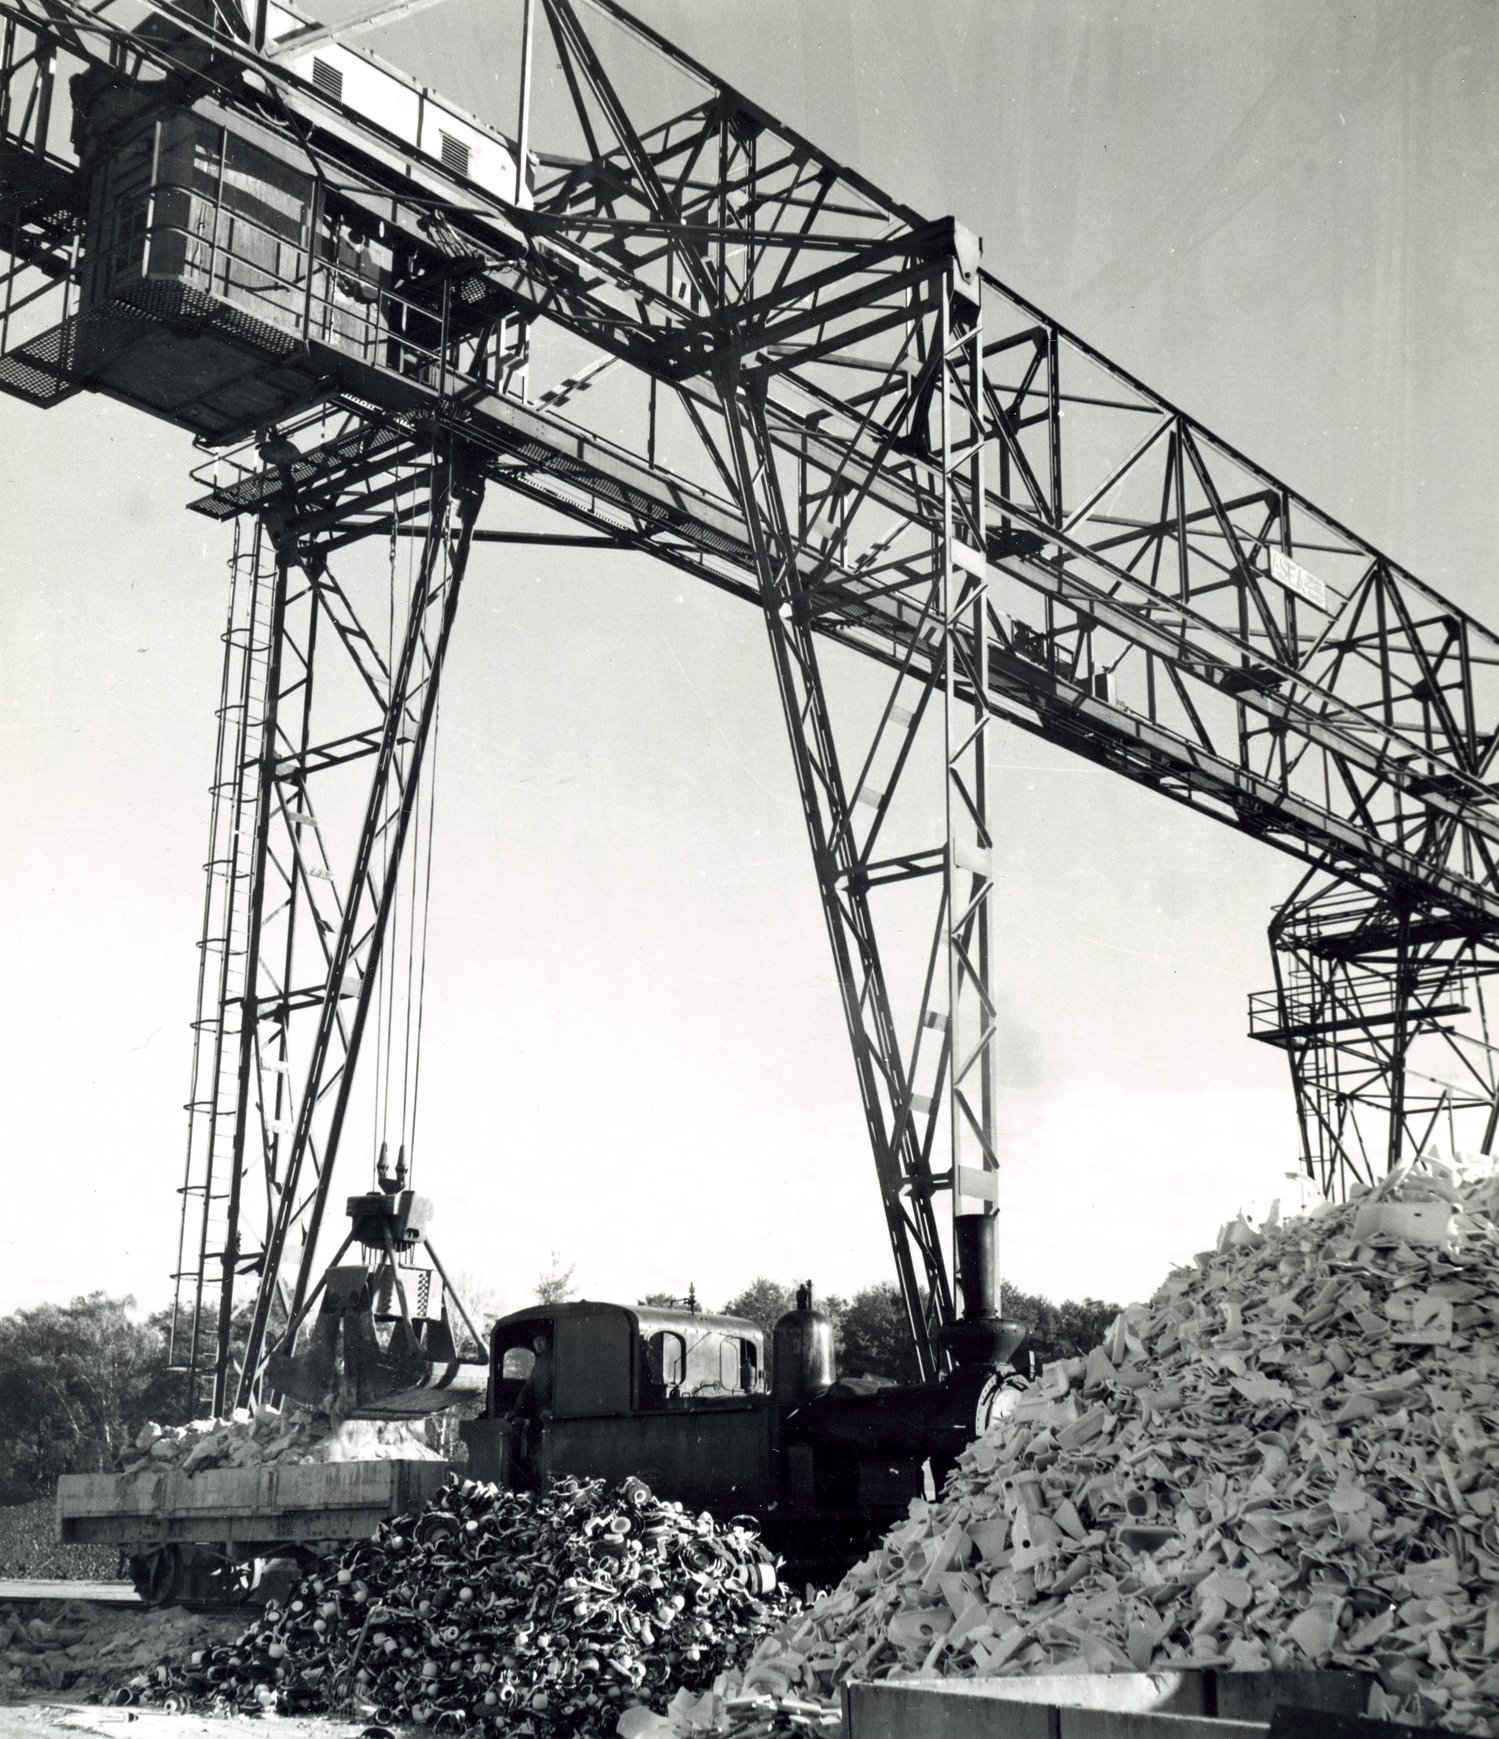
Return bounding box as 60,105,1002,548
71,5,523,440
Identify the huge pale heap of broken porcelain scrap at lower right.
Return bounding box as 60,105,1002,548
744,1162,1499,1736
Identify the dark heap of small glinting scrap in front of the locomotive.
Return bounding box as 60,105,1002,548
120,1480,791,1736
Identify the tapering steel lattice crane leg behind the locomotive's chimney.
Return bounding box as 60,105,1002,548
716,259,998,1379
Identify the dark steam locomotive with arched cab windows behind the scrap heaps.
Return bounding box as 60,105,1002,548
459,1289,1029,1576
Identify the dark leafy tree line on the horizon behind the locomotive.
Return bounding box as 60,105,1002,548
0,1256,1116,1504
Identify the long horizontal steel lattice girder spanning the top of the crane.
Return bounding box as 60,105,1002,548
0,0,1499,1356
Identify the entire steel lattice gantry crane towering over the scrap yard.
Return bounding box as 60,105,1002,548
0,0,1499,1405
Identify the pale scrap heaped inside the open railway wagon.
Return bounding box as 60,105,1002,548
118,1407,442,1473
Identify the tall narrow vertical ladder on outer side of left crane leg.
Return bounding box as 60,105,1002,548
169,522,276,1410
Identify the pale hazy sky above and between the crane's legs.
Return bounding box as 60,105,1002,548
0,0,1499,1309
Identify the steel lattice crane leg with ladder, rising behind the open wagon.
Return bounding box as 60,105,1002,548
174,449,483,1412
